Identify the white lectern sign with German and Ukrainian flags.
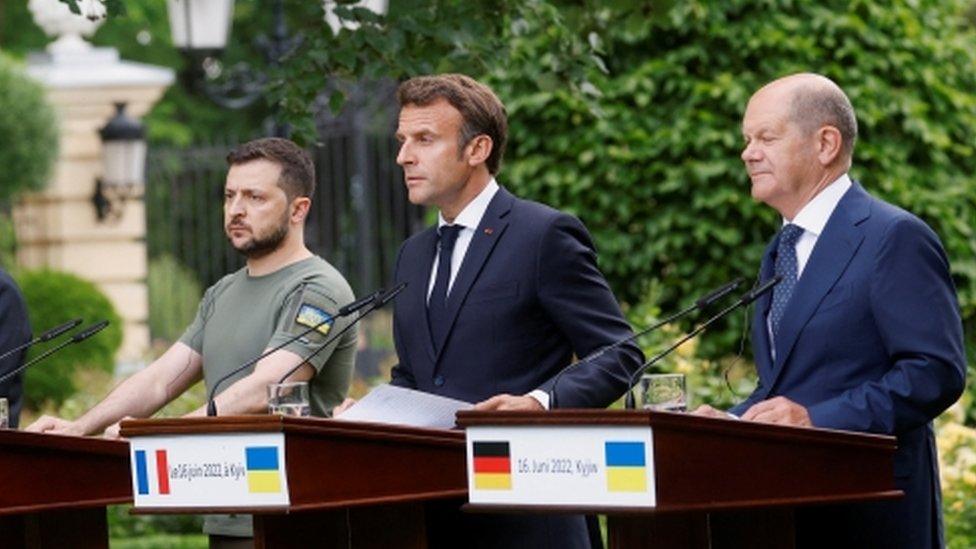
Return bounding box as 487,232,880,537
467,425,655,507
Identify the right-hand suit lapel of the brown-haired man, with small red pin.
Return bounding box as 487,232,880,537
431,188,515,358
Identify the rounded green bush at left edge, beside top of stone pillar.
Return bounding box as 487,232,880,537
0,53,58,202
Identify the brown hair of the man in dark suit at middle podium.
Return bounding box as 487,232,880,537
397,74,508,175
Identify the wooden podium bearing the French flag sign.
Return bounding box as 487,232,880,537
122,416,467,548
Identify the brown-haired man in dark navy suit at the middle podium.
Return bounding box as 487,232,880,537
393,75,642,549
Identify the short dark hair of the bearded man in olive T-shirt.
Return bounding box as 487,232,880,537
227,137,315,201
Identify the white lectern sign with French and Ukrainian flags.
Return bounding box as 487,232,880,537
130,433,288,507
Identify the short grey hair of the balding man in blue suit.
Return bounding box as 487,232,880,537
790,85,857,159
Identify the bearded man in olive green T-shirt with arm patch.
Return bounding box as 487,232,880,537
27,138,356,536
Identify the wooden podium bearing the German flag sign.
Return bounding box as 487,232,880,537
458,410,902,548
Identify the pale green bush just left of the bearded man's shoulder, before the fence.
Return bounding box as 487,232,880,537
146,254,203,342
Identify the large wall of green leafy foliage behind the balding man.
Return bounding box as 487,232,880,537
490,0,976,356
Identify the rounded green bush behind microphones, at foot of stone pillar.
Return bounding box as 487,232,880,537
16,270,122,409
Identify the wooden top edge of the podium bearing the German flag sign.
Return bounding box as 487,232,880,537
457,409,897,451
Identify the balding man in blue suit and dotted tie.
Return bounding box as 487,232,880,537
700,74,966,549
